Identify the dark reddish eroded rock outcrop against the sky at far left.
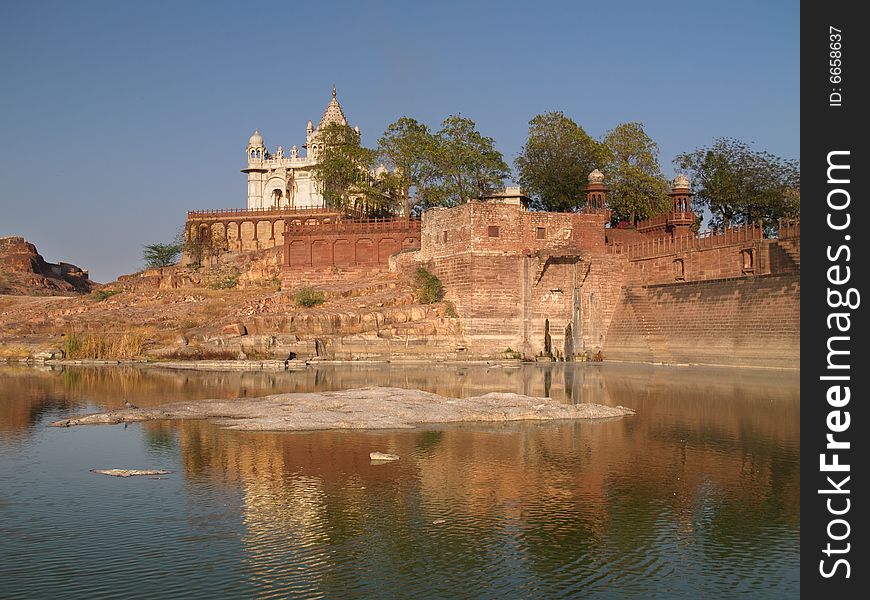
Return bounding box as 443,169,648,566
0,237,96,296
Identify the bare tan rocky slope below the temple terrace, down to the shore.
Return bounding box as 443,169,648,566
0,252,464,360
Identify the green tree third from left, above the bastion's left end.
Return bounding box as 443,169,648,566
434,115,510,206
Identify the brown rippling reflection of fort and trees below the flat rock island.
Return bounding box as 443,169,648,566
160,398,799,595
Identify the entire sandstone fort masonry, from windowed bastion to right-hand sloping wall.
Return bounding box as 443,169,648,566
406,202,800,367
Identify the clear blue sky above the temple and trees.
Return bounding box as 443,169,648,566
0,0,800,282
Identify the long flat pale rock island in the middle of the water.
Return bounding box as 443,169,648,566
51,387,634,431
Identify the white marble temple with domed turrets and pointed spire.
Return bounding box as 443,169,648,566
242,87,359,209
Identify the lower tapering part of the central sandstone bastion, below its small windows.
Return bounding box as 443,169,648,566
423,252,625,358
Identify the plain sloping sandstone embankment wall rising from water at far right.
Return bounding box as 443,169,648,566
604,274,800,367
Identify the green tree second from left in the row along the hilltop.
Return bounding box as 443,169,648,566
378,117,437,214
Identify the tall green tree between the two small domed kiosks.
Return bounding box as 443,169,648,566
602,123,669,225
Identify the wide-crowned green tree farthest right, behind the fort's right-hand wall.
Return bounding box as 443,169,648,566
674,137,800,228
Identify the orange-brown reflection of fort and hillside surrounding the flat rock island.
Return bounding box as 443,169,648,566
0,364,800,587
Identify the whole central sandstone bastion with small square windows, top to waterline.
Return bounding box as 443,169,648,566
417,202,612,357
